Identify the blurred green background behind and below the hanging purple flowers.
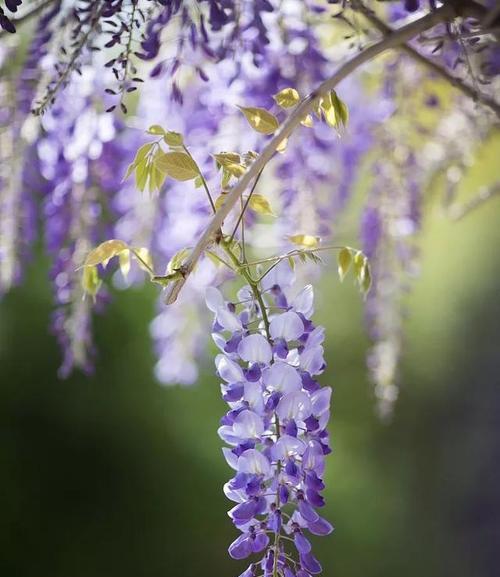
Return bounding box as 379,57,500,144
0,139,500,577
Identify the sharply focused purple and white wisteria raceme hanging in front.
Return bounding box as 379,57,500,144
207,265,333,577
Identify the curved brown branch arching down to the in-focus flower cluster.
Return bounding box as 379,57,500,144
166,5,455,304
